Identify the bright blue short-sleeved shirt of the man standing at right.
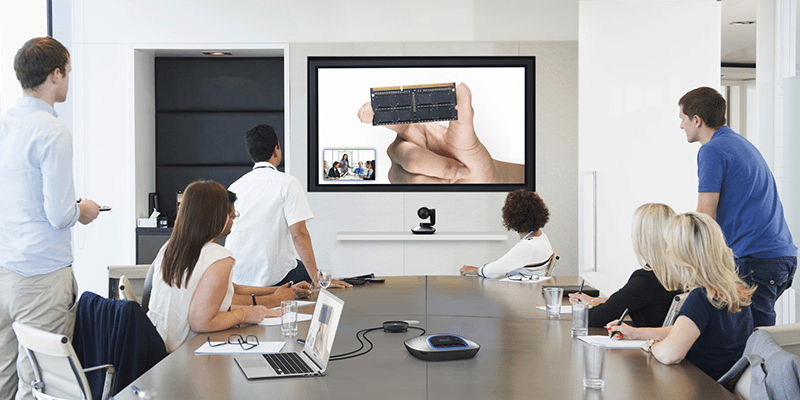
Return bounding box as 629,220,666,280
697,126,797,258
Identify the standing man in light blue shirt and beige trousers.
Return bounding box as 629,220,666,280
0,37,99,399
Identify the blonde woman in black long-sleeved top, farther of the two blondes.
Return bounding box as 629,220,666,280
569,204,683,327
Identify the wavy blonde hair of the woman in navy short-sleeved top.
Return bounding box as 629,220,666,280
655,212,755,313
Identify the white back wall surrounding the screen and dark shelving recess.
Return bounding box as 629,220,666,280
67,0,578,293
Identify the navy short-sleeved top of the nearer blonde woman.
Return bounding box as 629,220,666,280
678,288,754,380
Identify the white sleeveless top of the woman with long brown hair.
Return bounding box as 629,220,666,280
147,242,233,353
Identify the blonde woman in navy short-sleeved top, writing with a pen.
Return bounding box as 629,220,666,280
609,212,755,379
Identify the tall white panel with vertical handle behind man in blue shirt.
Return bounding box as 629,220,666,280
578,0,720,294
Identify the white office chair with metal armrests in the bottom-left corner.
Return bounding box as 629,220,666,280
12,322,114,400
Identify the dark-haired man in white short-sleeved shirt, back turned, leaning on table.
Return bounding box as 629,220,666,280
225,125,351,287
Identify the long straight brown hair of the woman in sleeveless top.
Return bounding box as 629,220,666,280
161,181,230,288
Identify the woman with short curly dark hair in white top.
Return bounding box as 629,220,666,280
460,189,553,278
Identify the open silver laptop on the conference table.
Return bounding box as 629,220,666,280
234,289,344,379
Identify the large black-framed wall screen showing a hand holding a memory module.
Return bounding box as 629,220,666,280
308,57,535,192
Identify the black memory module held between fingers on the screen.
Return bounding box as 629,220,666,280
370,83,458,125
